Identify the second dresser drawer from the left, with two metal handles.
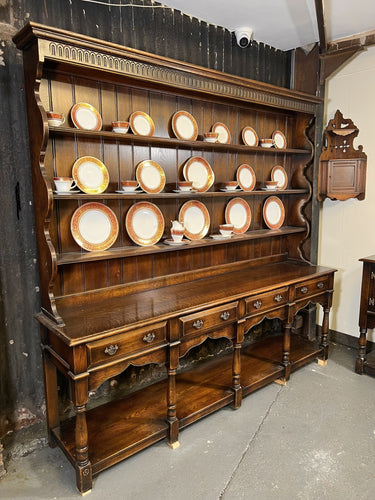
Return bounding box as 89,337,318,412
180,302,238,337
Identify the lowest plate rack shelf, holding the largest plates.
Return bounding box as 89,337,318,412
57,226,306,266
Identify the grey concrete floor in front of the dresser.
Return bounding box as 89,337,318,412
0,345,375,500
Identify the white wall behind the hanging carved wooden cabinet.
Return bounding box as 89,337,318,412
319,46,375,341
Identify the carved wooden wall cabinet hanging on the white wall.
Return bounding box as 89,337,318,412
318,110,367,201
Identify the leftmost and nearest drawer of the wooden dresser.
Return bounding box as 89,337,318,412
87,322,166,366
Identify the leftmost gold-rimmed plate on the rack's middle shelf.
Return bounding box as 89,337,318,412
72,156,109,194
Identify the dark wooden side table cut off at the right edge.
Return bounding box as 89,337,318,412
355,255,375,375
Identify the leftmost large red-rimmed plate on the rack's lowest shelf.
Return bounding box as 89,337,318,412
70,202,119,252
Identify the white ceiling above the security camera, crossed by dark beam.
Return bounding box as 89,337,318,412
163,0,375,50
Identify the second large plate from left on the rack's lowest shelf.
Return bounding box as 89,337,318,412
125,201,164,246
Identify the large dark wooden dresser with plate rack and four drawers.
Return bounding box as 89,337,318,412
14,23,334,493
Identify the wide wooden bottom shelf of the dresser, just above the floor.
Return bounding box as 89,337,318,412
53,335,320,474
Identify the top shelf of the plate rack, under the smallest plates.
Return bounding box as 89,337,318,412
49,127,311,155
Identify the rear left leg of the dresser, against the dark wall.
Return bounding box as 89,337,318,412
42,347,60,448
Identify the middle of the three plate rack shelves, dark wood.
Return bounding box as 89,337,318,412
53,189,308,200
